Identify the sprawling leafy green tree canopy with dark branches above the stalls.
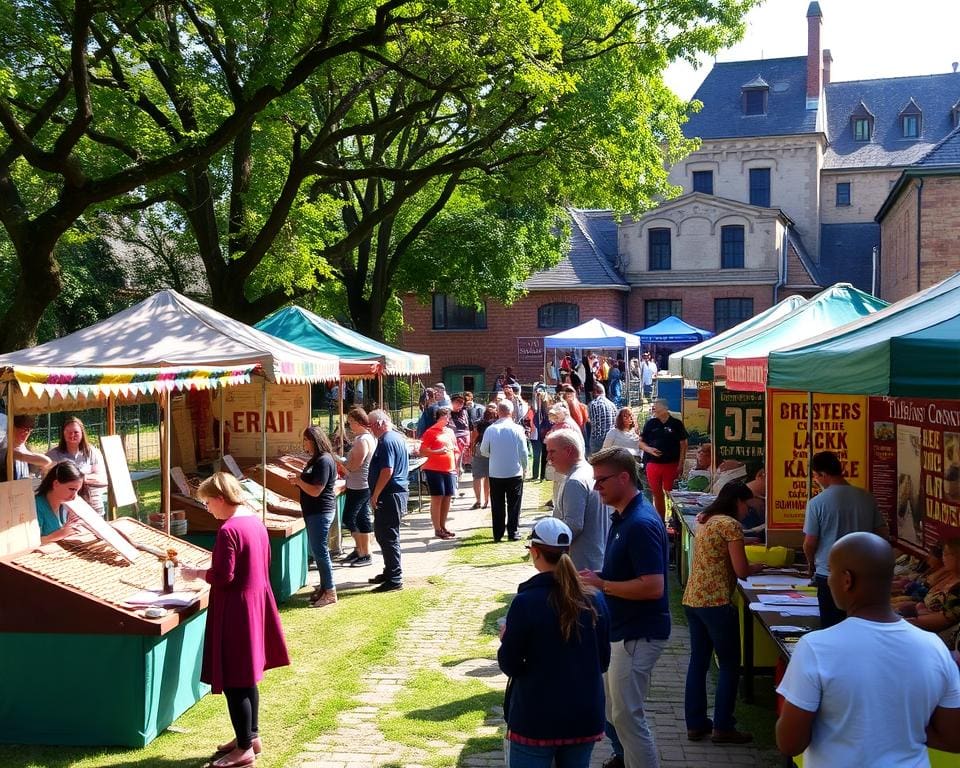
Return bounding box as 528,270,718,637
0,0,754,347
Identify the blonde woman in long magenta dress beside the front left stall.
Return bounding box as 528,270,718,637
183,472,290,768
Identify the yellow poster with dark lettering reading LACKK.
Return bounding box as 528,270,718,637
767,389,869,530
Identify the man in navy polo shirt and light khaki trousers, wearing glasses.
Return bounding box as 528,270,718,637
580,448,670,768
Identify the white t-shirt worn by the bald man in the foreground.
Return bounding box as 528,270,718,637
777,618,960,768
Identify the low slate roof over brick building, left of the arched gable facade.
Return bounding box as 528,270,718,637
523,208,629,291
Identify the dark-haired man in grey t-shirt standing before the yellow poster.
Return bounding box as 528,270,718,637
803,451,888,629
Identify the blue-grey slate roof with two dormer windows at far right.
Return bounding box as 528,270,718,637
824,72,960,168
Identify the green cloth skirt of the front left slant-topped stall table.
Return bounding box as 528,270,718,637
0,611,210,747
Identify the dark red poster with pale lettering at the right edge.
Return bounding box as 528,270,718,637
870,397,960,549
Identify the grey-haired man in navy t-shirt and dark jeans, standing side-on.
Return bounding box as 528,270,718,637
368,409,410,592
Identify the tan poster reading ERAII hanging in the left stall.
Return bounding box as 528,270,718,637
211,384,310,458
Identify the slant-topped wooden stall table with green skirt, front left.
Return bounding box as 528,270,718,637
0,518,210,747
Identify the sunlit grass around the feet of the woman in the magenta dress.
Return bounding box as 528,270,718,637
0,588,439,768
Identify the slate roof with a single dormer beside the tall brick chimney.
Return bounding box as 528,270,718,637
683,56,817,139
